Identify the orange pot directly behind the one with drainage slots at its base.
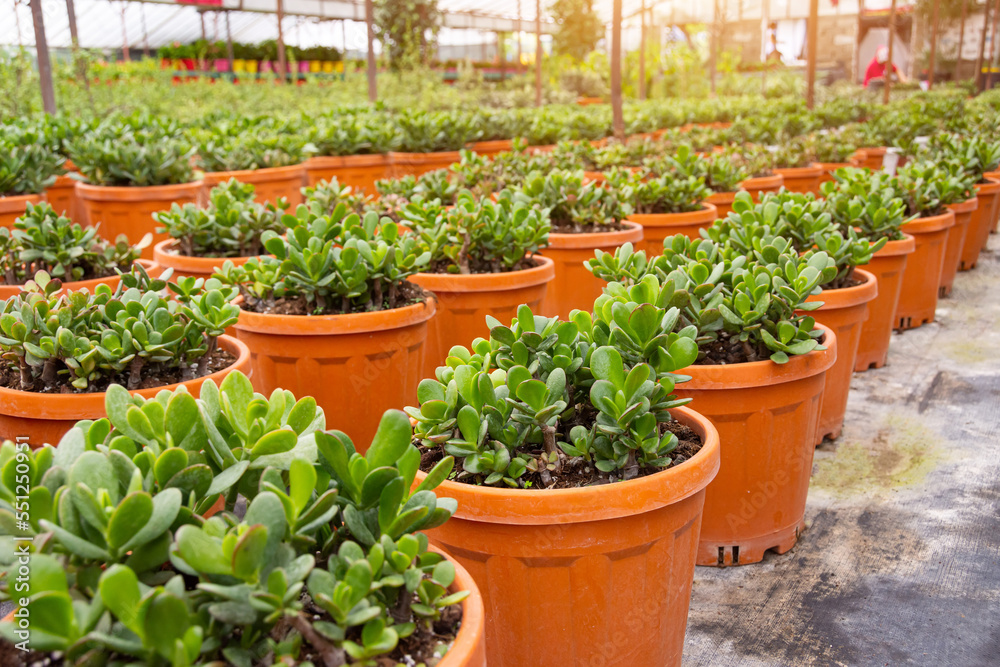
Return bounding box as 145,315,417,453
806,269,879,444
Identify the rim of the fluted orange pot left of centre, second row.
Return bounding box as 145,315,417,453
233,294,437,336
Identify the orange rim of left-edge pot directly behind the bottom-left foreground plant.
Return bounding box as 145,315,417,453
0,334,250,420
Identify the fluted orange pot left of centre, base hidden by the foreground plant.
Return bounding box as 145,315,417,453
235,297,435,452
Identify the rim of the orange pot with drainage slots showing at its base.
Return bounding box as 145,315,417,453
677,322,837,393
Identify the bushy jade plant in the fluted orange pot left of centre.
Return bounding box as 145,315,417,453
216,202,430,315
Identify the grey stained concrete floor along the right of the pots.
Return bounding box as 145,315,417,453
684,241,1000,667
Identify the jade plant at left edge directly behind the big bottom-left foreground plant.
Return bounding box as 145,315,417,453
0,265,239,392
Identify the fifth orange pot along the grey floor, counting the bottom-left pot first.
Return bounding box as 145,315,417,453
854,234,917,372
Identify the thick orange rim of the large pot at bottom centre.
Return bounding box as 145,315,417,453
414,407,720,526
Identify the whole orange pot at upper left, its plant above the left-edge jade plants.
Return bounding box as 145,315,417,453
76,181,202,259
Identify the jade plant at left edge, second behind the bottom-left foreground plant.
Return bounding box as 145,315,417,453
0,203,153,285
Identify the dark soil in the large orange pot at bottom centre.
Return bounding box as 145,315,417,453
417,419,703,489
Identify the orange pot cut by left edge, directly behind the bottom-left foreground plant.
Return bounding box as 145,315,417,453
0,336,251,447
